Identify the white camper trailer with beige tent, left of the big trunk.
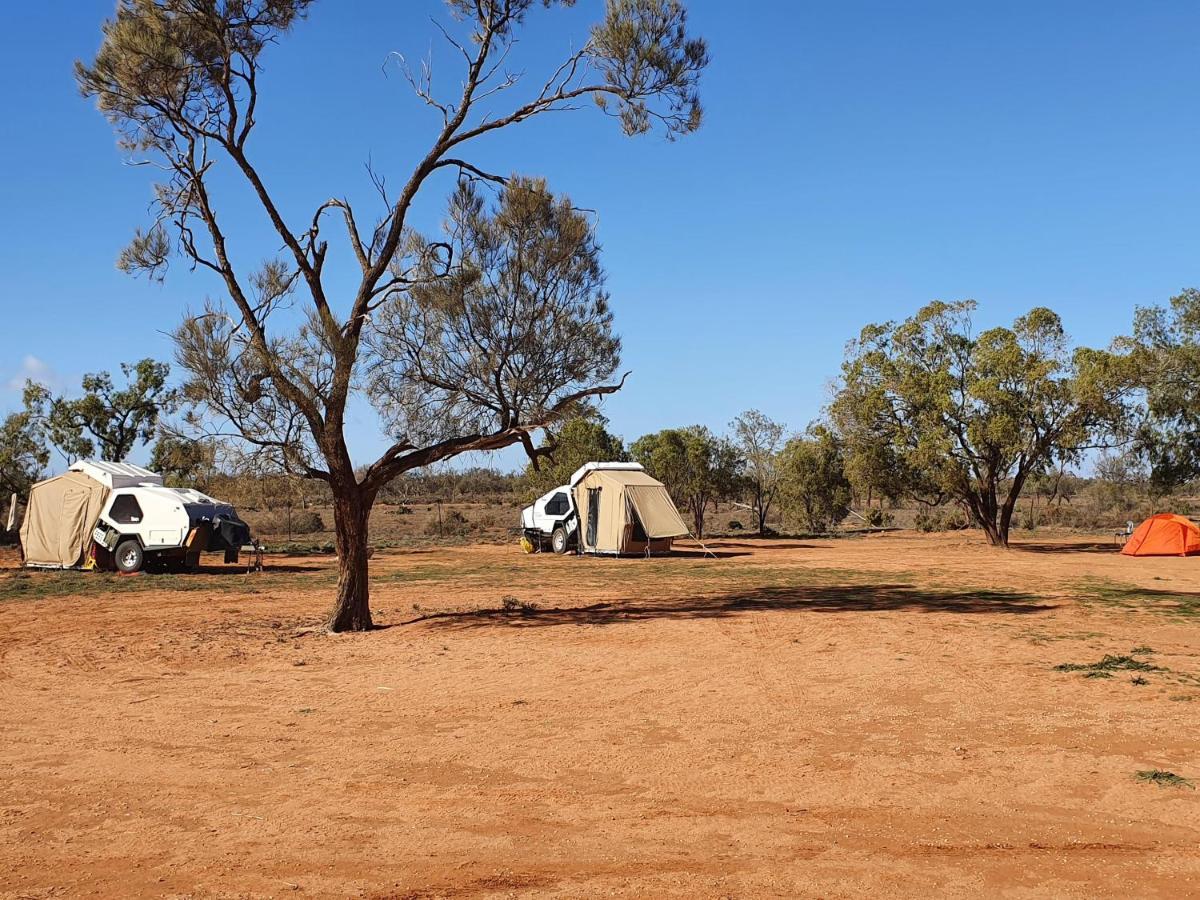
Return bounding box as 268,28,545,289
20,460,250,572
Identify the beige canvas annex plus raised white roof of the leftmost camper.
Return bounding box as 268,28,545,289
20,460,162,569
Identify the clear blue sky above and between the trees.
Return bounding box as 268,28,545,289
0,0,1200,466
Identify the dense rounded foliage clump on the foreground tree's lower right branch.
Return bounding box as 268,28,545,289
370,176,620,458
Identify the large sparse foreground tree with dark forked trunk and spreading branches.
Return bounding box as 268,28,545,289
77,0,708,631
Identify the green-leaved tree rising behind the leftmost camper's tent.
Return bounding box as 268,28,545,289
25,359,179,463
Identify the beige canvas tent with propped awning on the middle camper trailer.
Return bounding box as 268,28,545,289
571,464,688,553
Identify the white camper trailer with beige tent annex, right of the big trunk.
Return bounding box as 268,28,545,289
521,462,688,556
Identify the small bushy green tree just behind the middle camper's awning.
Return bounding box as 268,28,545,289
629,425,742,538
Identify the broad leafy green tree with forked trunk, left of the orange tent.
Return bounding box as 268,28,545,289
832,300,1132,546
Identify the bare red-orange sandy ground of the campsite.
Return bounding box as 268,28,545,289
0,534,1200,898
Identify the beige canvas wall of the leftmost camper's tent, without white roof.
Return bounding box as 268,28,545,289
20,472,108,569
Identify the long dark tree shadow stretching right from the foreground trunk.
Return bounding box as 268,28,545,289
401,584,1056,630
